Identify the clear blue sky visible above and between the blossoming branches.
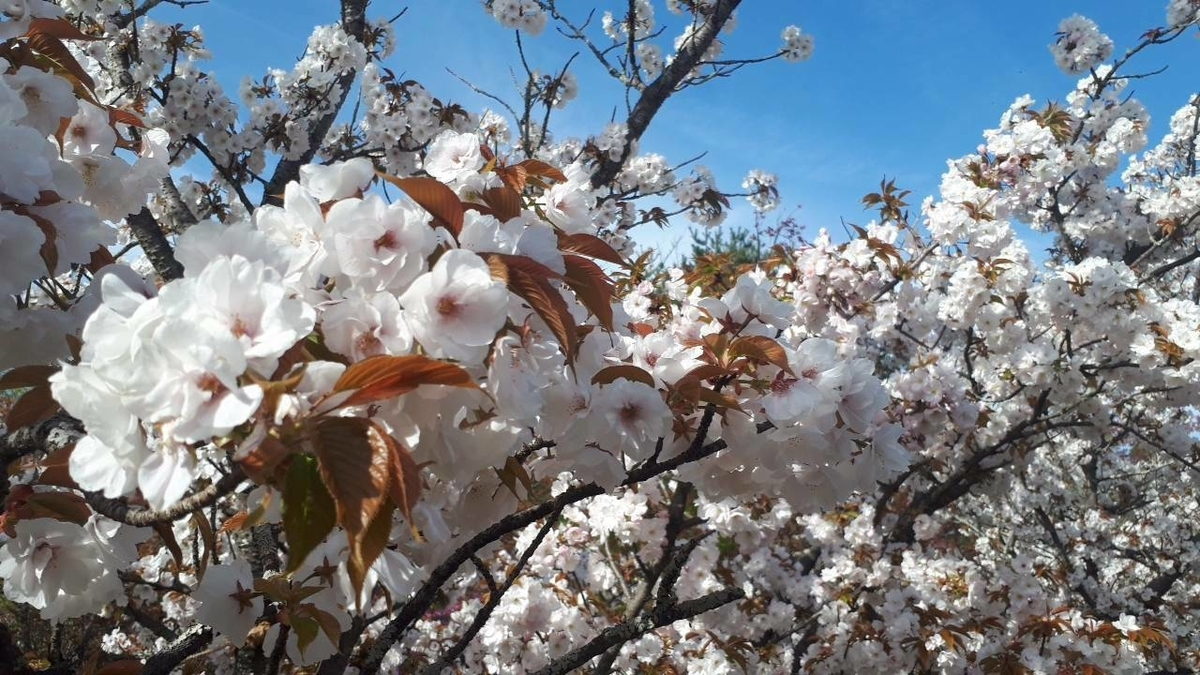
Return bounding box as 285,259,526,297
154,0,1200,257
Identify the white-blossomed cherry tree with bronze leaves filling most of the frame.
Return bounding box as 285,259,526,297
0,0,1200,675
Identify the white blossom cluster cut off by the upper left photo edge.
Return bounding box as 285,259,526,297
0,10,167,368
